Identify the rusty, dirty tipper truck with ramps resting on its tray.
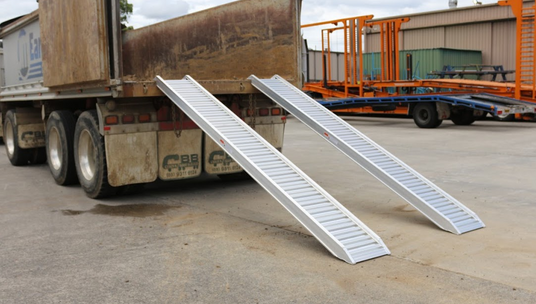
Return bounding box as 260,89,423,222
0,0,302,198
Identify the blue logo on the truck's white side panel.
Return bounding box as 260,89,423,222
18,29,43,81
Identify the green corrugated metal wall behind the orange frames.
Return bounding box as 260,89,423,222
363,48,482,80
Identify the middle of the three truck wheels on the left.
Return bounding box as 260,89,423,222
46,111,78,185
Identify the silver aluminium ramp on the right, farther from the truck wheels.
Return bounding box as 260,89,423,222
249,75,484,234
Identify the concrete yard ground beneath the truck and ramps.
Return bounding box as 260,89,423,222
0,117,536,303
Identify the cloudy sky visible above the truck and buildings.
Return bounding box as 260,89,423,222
0,0,497,49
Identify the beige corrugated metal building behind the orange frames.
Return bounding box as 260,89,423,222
309,0,534,80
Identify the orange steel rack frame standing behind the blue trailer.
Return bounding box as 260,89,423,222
302,0,536,108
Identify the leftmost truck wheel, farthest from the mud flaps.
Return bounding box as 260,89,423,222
4,110,30,166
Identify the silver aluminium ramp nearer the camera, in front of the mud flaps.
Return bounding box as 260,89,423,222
156,76,390,264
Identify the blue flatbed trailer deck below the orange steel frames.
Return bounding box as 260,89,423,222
317,93,536,117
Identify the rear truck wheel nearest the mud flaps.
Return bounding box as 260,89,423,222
74,110,116,198
